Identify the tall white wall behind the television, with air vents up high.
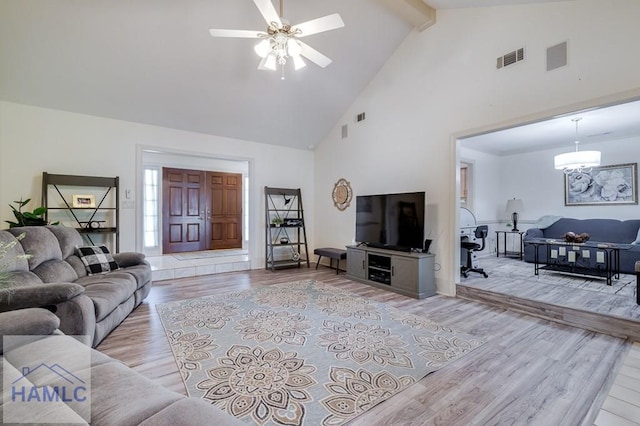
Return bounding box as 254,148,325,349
315,0,640,295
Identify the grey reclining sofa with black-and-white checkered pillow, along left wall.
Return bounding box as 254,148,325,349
0,226,151,347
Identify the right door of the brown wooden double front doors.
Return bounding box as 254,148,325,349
207,172,242,249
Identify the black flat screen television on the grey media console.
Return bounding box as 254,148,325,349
356,192,425,251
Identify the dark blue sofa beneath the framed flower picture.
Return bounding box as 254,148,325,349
523,218,640,274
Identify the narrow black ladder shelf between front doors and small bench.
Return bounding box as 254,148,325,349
264,186,309,271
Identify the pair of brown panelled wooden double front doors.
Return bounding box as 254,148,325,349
162,168,243,253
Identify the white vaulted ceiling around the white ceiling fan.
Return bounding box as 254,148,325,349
0,0,600,149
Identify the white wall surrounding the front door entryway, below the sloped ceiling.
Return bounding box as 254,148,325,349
0,102,314,268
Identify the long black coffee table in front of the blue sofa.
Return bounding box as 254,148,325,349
525,238,631,285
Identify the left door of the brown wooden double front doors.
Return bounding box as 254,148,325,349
162,167,207,253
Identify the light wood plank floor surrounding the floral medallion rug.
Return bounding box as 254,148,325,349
98,268,631,426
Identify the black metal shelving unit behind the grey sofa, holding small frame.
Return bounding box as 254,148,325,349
42,172,120,253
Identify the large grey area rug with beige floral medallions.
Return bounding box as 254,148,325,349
157,280,483,425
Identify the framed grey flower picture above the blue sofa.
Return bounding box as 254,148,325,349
564,163,638,206
